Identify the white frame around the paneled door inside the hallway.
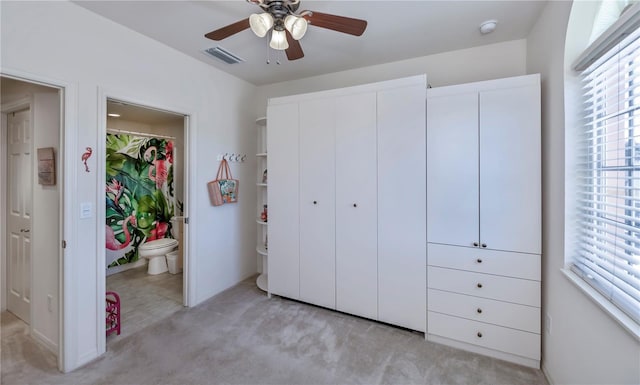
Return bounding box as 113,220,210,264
0,96,33,324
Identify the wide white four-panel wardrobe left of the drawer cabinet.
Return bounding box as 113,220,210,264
267,76,426,331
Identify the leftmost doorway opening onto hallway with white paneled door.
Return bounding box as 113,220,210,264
0,76,62,355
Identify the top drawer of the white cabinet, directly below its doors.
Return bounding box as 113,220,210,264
427,243,541,281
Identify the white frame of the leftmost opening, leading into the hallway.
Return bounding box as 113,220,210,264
0,67,78,372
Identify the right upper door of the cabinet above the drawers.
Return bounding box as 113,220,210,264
480,86,542,254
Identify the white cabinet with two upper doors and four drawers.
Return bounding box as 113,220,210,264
427,75,541,367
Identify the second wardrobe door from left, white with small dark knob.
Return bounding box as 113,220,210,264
300,99,336,308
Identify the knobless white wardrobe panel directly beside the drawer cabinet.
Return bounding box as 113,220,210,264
377,82,427,331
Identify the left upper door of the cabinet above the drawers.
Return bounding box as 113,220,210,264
427,92,479,247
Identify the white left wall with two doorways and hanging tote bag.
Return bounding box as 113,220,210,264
0,1,256,370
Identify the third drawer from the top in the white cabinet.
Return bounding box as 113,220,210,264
427,289,540,333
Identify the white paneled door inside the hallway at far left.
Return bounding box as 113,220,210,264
6,109,32,323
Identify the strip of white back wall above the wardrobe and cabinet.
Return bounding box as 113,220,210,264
255,40,527,116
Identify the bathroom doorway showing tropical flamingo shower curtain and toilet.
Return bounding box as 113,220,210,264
104,98,188,343
